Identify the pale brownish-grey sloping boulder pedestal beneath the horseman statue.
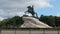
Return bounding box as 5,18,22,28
21,17,52,28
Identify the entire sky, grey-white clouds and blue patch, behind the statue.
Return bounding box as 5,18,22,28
0,0,60,20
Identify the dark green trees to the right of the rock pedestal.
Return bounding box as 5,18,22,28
39,15,60,27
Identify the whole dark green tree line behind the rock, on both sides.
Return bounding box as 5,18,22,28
0,15,60,28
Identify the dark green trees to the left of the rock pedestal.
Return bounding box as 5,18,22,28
0,16,24,28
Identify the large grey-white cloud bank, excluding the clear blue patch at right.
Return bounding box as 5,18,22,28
0,0,52,18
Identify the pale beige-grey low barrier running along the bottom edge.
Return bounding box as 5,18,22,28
0,30,60,34
